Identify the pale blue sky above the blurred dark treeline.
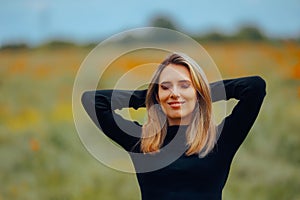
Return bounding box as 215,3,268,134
0,0,300,45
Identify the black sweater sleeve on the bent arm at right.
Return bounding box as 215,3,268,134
211,76,266,155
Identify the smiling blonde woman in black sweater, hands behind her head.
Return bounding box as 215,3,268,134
82,53,266,200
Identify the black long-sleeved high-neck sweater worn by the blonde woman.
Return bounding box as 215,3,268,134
82,76,266,200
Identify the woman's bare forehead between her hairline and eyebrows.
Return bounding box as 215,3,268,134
159,64,191,83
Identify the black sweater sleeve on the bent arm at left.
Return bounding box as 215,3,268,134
81,90,147,151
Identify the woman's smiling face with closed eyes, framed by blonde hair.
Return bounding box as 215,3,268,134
158,64,197,125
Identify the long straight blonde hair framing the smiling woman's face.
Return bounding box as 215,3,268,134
141,53,216,157
